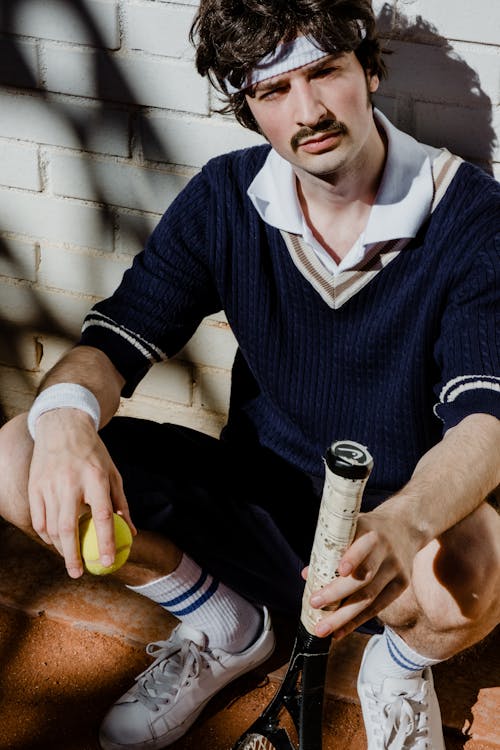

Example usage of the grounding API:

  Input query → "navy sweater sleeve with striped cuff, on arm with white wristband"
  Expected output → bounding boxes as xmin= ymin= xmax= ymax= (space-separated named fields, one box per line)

xmin=79 ymin=167 xmax=220 ymax=396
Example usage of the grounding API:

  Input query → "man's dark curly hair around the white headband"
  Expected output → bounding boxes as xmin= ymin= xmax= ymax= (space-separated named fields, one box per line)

xmin=189 ymin=0 xmax=386 ymax=131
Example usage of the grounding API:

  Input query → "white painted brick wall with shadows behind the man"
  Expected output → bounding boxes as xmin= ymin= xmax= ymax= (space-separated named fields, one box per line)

xmin=0 ymin=0 xmax=500 ymax=434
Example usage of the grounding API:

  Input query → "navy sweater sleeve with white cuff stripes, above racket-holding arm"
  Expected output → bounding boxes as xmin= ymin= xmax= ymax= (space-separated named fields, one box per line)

xmin=434 ymin=232 xmax=500 ymax=430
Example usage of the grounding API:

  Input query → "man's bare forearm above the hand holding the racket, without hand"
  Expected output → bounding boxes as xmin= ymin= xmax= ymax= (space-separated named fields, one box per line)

xmin=374 ymin=414 xmax=500 ymax=547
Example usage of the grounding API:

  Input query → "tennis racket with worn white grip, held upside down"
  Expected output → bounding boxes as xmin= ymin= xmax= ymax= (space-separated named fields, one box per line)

xmin=233 ymin=440 xmax=373 ymax=750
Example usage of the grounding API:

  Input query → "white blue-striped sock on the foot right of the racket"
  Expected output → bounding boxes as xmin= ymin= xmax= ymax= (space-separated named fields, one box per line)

xmin=364 ymin=626 xmax=440 ymax=685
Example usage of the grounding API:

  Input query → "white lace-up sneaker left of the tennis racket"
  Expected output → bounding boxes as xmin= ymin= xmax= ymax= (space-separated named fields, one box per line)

xmin=99 ymin=608 xmax=275 ymax=750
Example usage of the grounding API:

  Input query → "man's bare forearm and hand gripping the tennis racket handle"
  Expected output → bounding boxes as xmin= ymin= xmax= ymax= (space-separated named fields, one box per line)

xmin=305 ymin=414 xmax=500 ymax=638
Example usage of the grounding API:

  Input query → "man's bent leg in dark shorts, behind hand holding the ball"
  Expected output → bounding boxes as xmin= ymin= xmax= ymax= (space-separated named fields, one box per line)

xmin=0 ymin=415 xmax=319 ymax=615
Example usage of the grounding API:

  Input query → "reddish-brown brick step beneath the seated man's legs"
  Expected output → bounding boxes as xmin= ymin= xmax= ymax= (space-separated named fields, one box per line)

xmin=0 ymin=524 xmax=500 ymax=750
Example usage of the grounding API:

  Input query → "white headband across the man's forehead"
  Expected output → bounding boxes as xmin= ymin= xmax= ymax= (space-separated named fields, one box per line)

xmin=224 ymin=21 xmax=366 ymax=94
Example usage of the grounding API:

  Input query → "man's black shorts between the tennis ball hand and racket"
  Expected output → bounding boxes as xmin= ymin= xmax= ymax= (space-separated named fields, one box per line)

xmin=100 ymin=417 xmax=384 ymax=636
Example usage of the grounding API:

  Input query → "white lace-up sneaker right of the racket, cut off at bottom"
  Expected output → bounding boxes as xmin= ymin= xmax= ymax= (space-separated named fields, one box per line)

xmin=358 ymin=635 xmax=445 ymax=750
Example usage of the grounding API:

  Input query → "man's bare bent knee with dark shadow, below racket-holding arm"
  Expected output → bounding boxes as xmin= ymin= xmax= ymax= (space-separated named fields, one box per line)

xmin=381 ymin=503 xmax=500 ymax=659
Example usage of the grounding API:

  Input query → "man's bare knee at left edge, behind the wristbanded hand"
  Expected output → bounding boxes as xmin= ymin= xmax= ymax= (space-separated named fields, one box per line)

xmin=0 ymin=414 xmax=34 ymax=534
